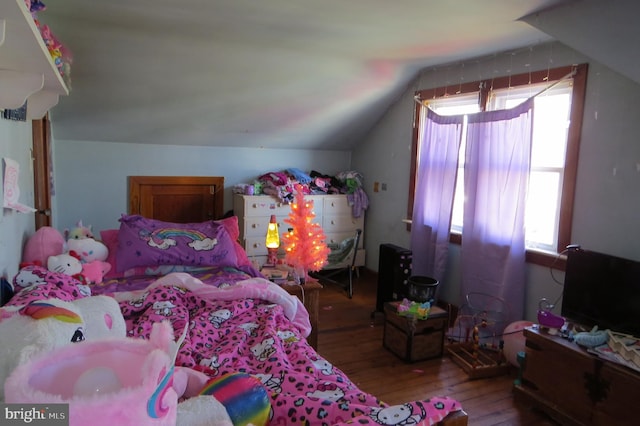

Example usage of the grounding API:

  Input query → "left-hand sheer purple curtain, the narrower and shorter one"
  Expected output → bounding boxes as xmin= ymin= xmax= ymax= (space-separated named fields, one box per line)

xmin=411 ymin=108 xmax=464 ymax=281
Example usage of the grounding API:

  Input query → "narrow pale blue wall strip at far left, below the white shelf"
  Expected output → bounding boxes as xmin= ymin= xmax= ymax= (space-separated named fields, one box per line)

xmin=0 ymin=119 xmax=35 ymax=282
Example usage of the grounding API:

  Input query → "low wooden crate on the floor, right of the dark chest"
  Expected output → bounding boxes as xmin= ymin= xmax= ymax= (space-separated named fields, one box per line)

xmin=447 ymin=342 xmax=509 ymax=379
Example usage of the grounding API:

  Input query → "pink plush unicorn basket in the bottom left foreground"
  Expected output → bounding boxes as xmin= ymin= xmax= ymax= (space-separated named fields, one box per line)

xmin=5 ymin=322 xmax=178 ymax=426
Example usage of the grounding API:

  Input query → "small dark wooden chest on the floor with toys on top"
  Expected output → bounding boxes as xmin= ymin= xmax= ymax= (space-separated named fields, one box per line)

xmin=383 ymin=302 xmax=448 ymax=362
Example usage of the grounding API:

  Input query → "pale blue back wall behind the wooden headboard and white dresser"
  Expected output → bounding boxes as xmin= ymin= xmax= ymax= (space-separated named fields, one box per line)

xmin=53 ymin=139 xmax=351 ymax=232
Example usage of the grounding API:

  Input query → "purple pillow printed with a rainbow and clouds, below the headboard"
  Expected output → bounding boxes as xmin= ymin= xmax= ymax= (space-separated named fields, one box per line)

xmin=116 ymin=214 xmax=238 ymax=272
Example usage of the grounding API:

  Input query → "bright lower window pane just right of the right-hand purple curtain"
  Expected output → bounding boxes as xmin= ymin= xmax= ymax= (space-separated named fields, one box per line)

xmin=525 ymin=172 xmax=560 ymax=250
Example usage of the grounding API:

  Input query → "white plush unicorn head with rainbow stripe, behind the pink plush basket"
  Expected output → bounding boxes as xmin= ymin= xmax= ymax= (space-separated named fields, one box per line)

xmin=0 ymin=296 xmax=126 ymax=400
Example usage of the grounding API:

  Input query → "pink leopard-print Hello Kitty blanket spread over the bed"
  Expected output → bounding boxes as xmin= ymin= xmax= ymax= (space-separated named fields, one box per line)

xmin=7 ymin=273 xmax=461 ymax=425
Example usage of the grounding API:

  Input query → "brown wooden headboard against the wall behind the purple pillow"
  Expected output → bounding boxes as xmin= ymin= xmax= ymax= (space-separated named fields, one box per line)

xmin=129 ymin=176 xmax=224 ymax=223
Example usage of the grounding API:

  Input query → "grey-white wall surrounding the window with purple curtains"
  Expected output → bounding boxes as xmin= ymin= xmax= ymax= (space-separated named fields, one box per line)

xmin=352 ymin=43 xmax=640 ymax=321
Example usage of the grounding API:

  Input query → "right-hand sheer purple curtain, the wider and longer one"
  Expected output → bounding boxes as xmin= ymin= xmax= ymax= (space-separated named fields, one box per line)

xmin=461 ymin=99 xmax=533 ymax=323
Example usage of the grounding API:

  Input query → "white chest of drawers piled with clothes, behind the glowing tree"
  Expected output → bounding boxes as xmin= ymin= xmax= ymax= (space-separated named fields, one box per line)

xmin=233 ymin=194 xmax=365 ymax=266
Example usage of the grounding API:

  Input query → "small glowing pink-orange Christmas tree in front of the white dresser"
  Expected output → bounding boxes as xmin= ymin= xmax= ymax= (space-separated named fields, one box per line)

xmin=282 ymin=185 xmax=329 ymax=278
